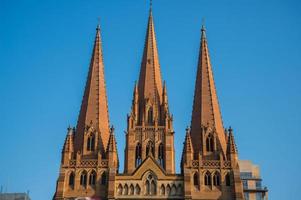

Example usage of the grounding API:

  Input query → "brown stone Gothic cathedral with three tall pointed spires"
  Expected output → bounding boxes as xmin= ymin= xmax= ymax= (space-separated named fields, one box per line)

xmin=53 ymin=6 xmax=244 ymax=200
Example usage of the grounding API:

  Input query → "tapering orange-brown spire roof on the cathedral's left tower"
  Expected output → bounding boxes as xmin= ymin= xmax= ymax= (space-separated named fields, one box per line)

xmin=76 ymin=25 xmax=109 ymax=150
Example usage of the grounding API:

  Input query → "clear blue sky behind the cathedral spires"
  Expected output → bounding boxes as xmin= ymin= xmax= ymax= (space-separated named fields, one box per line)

xmin=0 ymin=0 xmax=301 ymax=200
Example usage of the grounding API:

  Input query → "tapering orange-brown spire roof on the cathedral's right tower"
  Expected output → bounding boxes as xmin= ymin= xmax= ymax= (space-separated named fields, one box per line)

xmin=191 ymin=25 xmax=226 ymax=153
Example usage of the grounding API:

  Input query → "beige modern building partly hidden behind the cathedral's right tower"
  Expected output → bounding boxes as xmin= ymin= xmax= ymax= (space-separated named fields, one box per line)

xmin=239 ymin=160 xmax=268 ymax=200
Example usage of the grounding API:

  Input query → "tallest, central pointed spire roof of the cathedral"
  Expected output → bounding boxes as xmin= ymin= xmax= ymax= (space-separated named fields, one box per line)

xmin=138 ymin=8 xmax=162 ymax=102
